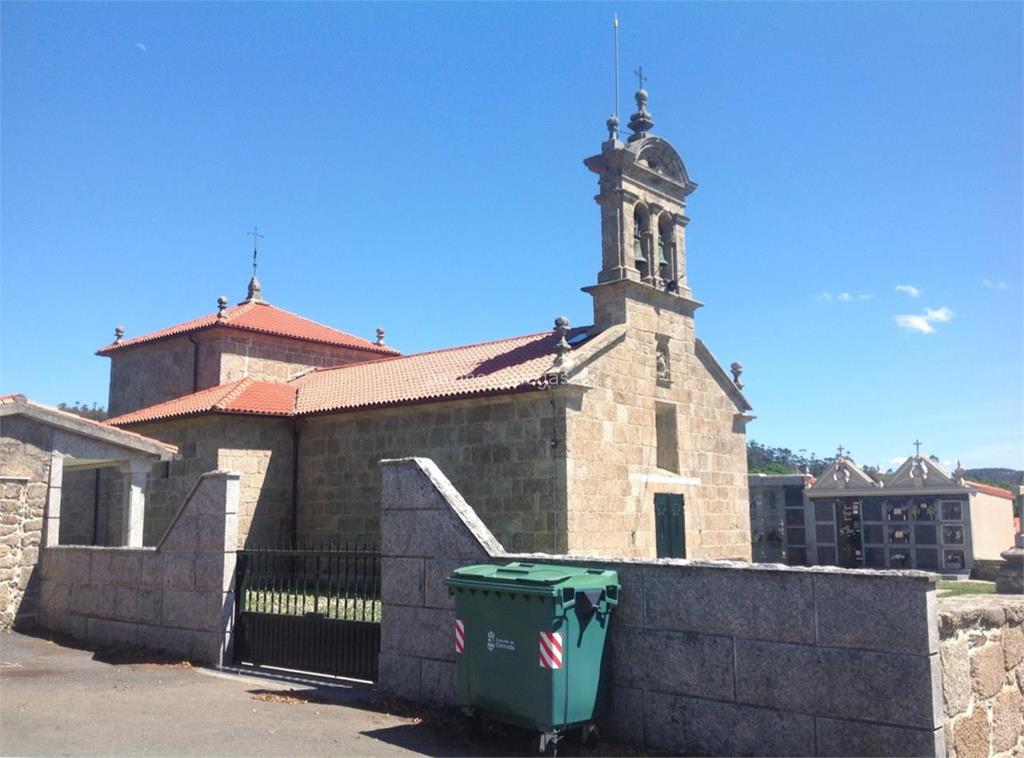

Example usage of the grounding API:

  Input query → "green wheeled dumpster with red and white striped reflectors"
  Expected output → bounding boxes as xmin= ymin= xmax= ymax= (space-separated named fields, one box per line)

xmin=447 ymin=562 xmax=621 ymax=750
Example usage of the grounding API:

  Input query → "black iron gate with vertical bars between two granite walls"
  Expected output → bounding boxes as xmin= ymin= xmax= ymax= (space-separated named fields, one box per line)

xmin=234 ymin=545 xmax=381 ymax=680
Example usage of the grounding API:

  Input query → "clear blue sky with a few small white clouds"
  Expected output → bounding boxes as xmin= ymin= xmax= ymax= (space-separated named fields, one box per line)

xmin=0 ymin=2 xmax=1024 ymax=467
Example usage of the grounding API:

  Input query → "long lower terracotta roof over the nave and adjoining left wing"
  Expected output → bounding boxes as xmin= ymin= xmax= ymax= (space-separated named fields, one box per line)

xmin=106 ymin=327 xmax=587 ymax=426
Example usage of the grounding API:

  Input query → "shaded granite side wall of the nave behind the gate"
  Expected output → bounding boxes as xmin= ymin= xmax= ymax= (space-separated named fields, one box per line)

xmin=299 ymin=391 xmax=565 ymax=552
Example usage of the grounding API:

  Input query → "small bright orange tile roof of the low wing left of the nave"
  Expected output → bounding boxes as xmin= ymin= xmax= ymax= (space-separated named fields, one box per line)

xmin=104 ymin=378 xmax=295 ymax=426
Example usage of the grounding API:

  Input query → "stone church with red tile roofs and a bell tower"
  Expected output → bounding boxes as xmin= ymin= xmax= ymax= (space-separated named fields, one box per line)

xmin=63 ymin=90 xmax=753 ymax=559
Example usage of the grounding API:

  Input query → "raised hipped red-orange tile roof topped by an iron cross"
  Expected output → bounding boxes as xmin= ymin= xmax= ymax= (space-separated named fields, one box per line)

xmin=96 ymin=300 xmax=398 ymax=355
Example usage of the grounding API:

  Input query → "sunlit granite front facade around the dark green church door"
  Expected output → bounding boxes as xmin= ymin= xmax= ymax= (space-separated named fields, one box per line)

xmin=569 ymin=287 xmax=751 ymax=560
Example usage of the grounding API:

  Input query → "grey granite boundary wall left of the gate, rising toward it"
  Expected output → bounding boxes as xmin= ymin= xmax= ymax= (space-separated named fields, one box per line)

xmin=39 ymin=471 xmax=240 ymax=666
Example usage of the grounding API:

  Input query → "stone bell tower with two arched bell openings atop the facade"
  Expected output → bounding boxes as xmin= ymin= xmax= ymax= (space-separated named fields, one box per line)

xmin=584 ymin=80 xmax=700 ymax=328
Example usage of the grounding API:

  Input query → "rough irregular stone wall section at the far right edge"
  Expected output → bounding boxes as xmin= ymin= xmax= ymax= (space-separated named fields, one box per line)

xmin=939 ymin=595 xmax=1024 ymax=758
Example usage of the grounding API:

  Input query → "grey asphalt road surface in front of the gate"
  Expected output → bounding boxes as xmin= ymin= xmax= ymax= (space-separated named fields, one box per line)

xmin=0 ymin=633 xmax=499 ymax=756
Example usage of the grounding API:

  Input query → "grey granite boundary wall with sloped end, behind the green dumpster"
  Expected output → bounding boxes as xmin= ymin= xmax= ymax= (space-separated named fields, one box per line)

xmin=379 ymin=459 xmax=945 ymax=755
